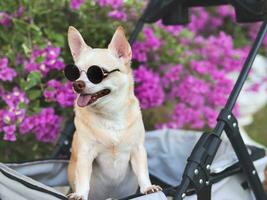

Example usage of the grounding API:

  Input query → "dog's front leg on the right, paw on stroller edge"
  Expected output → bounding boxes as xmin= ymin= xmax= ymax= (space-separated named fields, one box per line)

xmin=131 ymin=144 xmax=162 ymax=194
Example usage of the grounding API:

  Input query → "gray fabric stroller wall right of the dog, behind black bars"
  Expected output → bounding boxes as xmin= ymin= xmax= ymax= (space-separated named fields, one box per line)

xmin=145 ymin=129 xmax=240 ymax=185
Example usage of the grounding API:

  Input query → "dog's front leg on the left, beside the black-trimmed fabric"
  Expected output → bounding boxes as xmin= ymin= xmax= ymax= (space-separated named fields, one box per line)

xmin=68 ymin=150 xmax=94 ymax=200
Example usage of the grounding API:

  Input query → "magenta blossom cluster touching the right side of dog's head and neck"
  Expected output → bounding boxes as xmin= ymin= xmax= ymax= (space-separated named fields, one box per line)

xmin=134 ymin=65 xmax=164 ymax=109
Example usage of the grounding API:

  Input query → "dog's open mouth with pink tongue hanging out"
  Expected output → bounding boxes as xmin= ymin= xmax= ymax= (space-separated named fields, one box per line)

xmin=77 ymin=89 xmax=110 ymax=107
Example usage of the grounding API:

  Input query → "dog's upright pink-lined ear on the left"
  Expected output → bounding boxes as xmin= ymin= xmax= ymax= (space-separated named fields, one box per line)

xmin=68 ymin=26 xmax=91 ymax=61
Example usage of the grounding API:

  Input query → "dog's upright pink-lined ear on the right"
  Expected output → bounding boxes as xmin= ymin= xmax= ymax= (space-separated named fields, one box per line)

xmin=108 ymin=26 xmax=132 ymax=64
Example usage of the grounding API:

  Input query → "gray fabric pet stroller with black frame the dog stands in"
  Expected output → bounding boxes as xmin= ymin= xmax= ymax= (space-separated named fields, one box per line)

xmin=0 ymin=0 xmax=267 ymax=200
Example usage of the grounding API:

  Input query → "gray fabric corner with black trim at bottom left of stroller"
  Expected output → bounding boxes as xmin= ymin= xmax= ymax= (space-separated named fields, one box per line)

xmin=0 ymin=163 xmax=66 ymax=200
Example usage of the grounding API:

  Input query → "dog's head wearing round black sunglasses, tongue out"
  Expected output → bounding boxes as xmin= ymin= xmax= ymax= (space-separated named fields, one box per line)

xmin=68 ymin=27 xmax=133 ymax=107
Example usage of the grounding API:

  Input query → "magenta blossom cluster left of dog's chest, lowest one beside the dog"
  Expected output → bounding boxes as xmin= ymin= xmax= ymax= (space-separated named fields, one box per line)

xmin=20 ymin=108 xmax=62 ymax=142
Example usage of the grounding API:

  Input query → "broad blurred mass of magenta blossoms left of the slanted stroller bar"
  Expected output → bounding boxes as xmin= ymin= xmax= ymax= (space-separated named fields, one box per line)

xmin=158 ymin=32 xmax=247 ymax=129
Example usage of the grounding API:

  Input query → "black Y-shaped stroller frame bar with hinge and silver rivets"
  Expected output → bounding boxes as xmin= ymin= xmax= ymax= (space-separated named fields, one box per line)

xmin=173 ymin=21 xmax=267 ymax=200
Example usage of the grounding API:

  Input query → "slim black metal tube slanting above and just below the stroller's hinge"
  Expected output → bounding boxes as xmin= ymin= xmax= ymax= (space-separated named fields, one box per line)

xmin=213 ymin=21 xmax=267 ymax=136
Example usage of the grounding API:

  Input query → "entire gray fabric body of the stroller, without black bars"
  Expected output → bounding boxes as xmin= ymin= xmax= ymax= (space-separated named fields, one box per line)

xmin=0 ymin=129 xmax=267 ymax=200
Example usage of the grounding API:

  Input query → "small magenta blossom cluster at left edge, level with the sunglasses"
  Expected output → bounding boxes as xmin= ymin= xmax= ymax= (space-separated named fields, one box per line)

xmin=0 ymin=58 xmax=17 ymax=81
